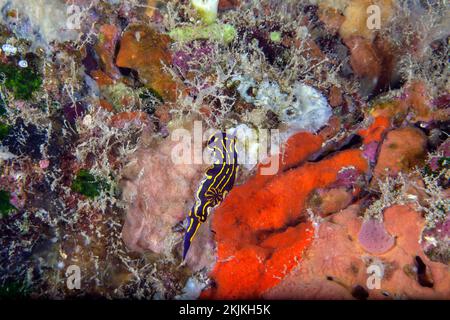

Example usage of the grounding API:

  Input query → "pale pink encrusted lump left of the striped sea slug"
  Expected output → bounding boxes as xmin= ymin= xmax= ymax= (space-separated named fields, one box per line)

xmin=122 ymin=137 xmax=206 ymax=255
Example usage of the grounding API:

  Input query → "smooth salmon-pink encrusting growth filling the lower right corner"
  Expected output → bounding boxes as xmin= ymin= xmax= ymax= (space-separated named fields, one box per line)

xmin=264 ymin=205 xmax=450 ymax=299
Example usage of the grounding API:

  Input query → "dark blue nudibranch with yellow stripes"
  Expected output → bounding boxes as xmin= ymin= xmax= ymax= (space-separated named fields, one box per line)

xmin=183 ymin=132 xmax=239 ymax=260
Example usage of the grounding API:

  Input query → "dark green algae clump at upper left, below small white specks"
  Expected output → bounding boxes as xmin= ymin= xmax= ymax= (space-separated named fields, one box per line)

xmin=0 ymin=63 xmax=42 ymax=100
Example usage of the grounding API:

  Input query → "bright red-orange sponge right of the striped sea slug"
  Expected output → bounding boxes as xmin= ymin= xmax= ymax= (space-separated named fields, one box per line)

xmin=202 ymin=133 xmax=368 ymax=299
